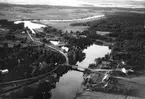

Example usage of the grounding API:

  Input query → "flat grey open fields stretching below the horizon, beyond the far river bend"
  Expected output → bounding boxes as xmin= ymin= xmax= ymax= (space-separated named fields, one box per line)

xmin=0 ymin=3 xmax=144 ymax=20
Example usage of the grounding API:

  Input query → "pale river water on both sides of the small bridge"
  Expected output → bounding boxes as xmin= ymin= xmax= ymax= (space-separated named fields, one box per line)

xmin=51 ymin=44 xmax=110 ymax=99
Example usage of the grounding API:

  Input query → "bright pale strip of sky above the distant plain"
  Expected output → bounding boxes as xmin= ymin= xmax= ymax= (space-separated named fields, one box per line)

xmin=0 ymin=0 xmax=145 ymax=8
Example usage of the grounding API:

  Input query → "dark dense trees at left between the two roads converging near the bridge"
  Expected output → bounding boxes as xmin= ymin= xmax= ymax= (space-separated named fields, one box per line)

xmin=0 ymin=44 xmax=66 ymax=81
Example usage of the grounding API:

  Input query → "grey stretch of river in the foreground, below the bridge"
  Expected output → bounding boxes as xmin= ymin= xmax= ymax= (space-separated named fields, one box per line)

xmin=51 ymin=71 xmax=83 ymax=99
